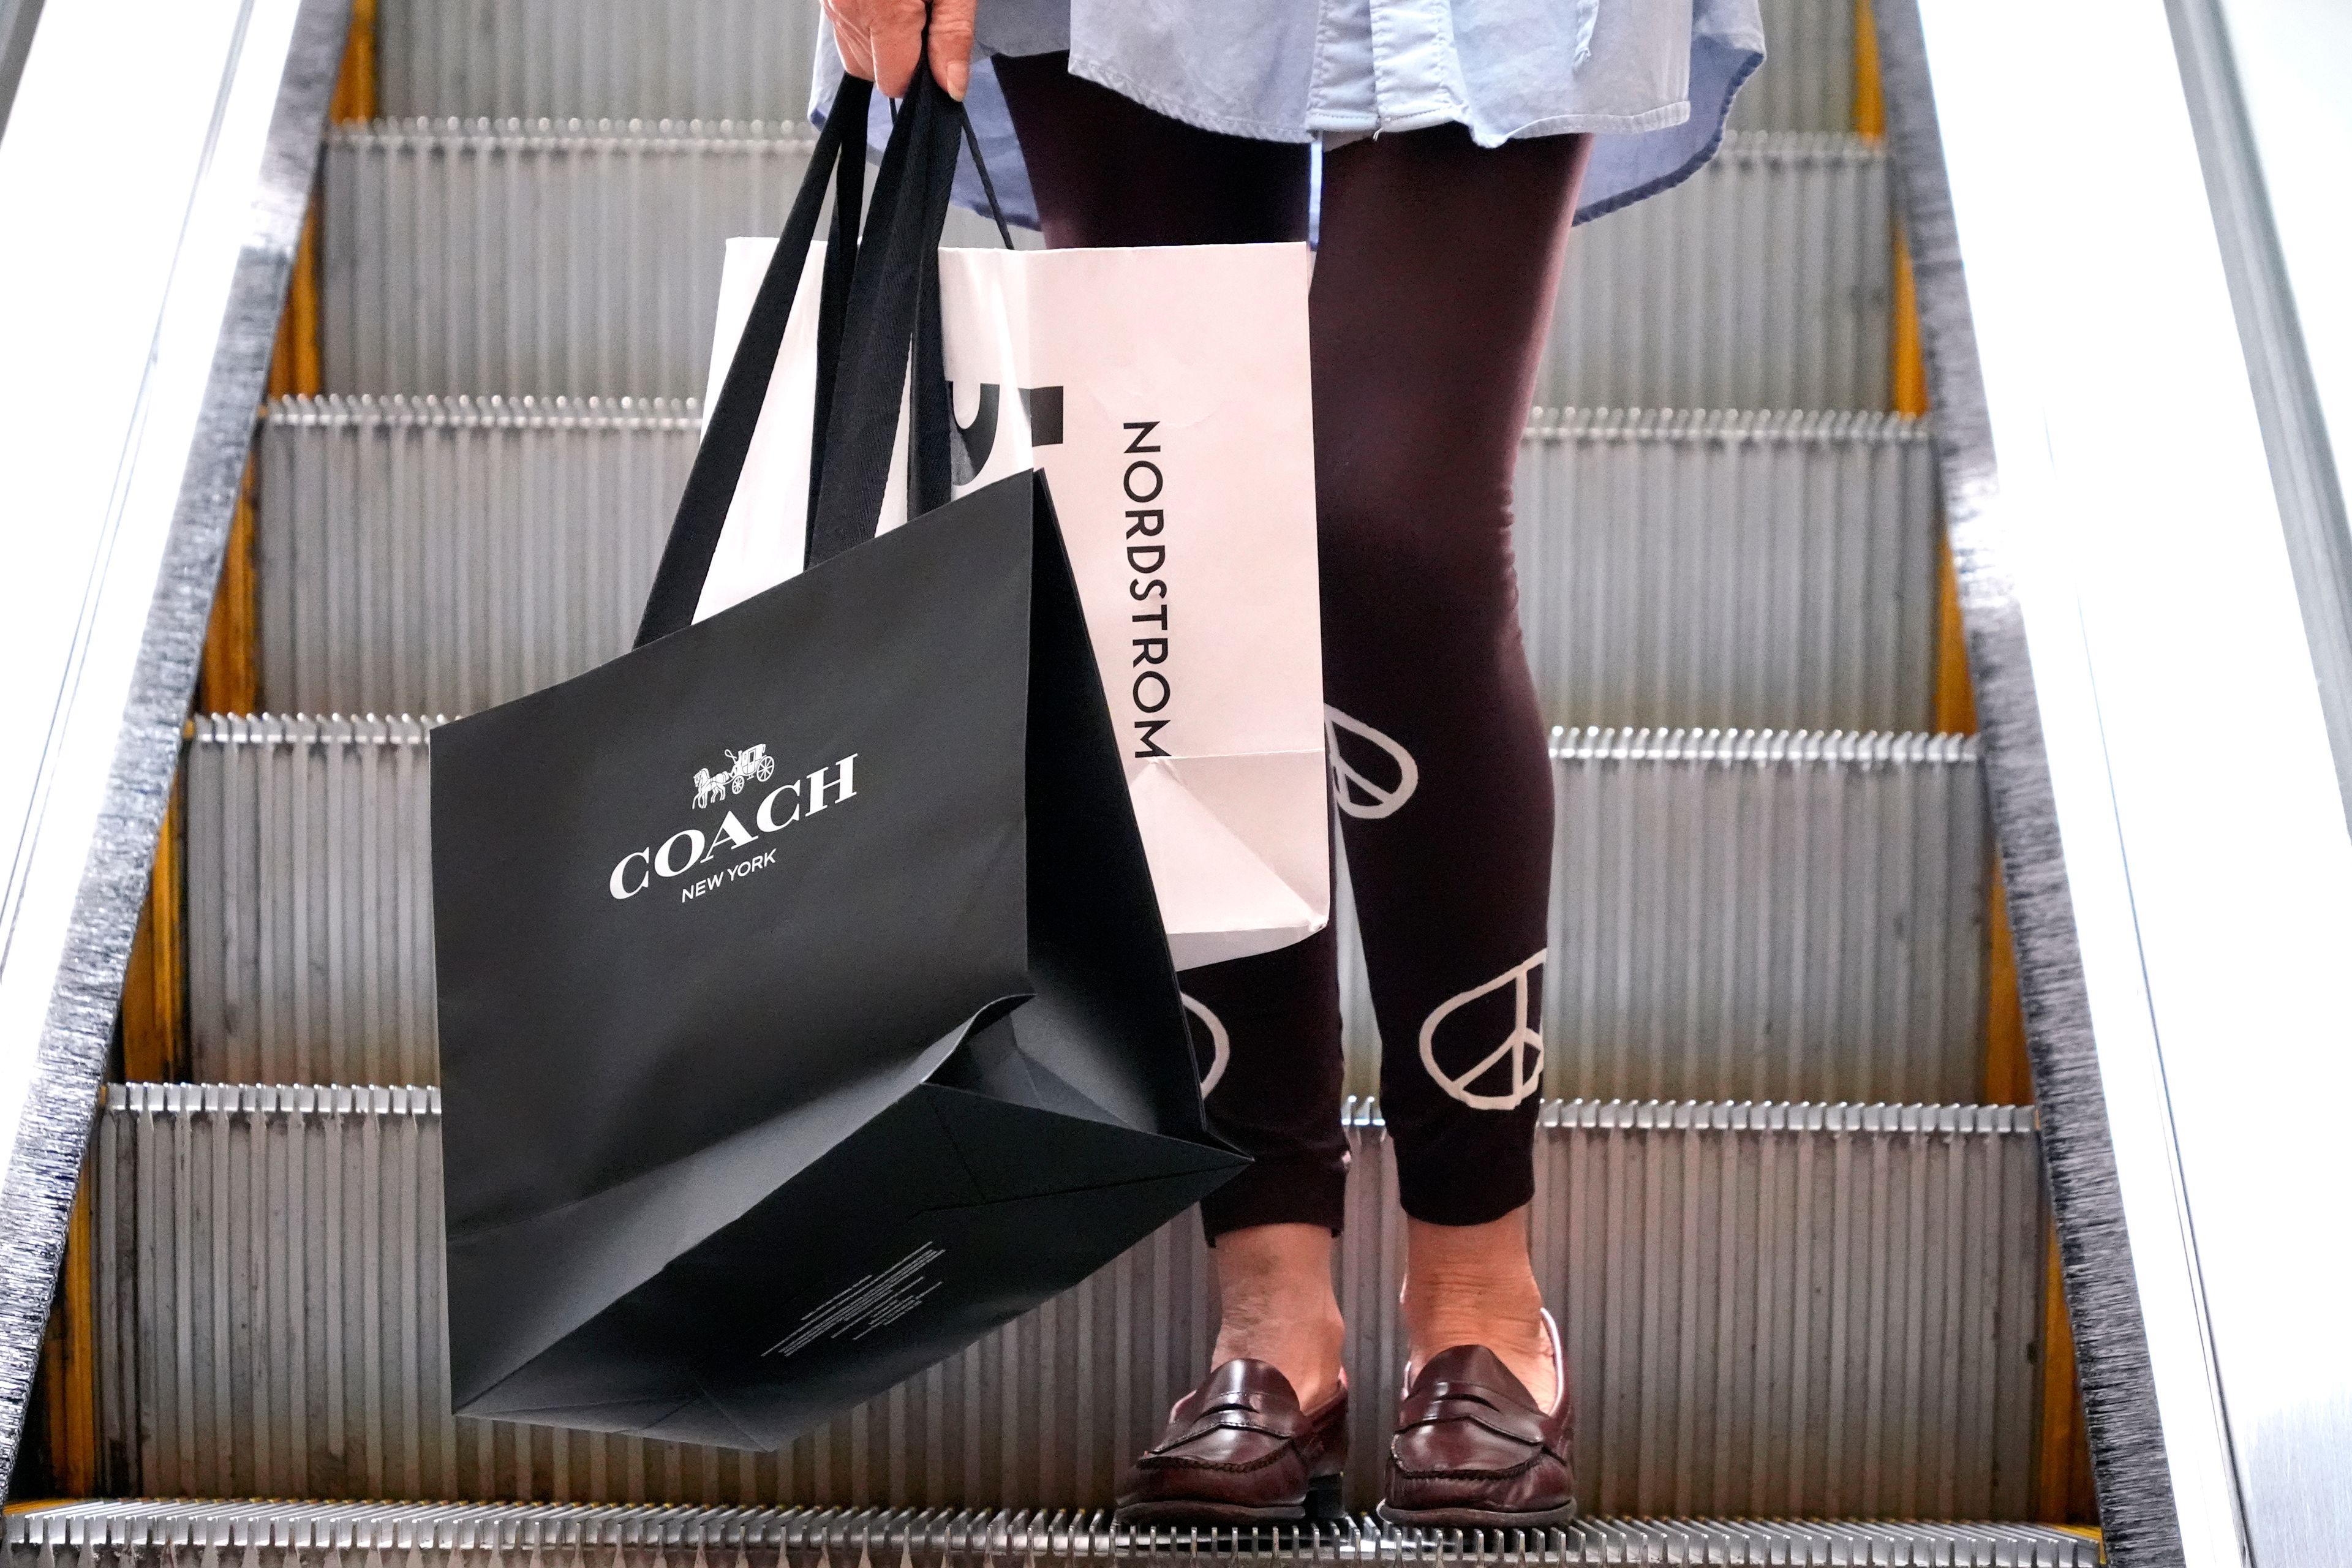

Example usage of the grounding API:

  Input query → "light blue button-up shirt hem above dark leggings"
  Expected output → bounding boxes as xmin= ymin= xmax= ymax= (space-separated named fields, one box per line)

xmin=809 ymin=0 xmax=1764 ymax=228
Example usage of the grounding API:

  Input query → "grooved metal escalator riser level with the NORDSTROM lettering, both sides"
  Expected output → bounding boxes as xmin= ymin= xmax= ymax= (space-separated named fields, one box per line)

xmin=257 ymin=398 xmax=1940 ymax=729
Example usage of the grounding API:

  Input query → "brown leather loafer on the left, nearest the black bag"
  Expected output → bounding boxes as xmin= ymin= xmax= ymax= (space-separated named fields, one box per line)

xmin=1117 ymin=1359 xmax=1348 ymax=1526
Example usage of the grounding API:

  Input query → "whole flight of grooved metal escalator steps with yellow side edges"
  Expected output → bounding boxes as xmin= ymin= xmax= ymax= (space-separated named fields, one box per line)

xmin=18 ymin=0 xmax=2352 ymax=1568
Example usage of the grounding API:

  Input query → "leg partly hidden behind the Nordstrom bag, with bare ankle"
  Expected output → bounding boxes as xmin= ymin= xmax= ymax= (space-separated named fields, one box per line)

xmin=995 ymin=54 xmax=1348 ymax=1411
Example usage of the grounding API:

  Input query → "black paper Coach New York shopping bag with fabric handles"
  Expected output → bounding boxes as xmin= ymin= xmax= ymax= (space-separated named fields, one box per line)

xmin=433 ymin=73 xmax=1242 ymax=1448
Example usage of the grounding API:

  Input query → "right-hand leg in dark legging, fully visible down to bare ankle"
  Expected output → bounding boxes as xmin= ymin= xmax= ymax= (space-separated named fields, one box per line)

xmin=1313 ymin=127 xmax=1590 ymax=1406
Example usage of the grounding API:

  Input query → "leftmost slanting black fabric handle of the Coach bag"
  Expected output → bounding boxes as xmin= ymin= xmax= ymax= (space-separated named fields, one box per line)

xmin=635 ymin=75 xmax=873 ymax=649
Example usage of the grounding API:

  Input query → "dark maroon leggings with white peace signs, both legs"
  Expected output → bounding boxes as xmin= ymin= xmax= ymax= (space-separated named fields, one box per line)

xmin=997 ymin=54 xmax=1593 ymax=1239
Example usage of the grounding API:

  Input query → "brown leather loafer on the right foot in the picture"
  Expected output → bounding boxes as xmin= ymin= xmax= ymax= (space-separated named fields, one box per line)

xmin=1381 ymin=1312 xmax=1576 ymax=1531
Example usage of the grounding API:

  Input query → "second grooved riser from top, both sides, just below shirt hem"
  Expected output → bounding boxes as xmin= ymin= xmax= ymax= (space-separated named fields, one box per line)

xmin=320 ymin=120 xmax=1893 ymax=409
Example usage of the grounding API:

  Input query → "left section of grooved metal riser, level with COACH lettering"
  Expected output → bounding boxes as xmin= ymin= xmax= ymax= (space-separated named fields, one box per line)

xmin=186 ymin=715 xmax=440 ymax=1084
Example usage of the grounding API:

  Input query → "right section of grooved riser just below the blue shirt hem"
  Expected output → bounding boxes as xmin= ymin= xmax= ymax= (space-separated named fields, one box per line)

xmin=1536 ymin=134 xmax=1893 ymax=409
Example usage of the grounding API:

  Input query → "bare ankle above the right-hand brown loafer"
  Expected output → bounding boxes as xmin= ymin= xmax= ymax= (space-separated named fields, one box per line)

xmin=1404 ymin=1208 xmax=1559 ymax=1411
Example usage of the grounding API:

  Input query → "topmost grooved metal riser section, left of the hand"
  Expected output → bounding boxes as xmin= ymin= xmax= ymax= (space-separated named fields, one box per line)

xmin=376 ymin=0 xmax=827 ymax=120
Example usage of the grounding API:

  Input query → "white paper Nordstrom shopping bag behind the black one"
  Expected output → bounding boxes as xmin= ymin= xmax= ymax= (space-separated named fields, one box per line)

xmin=696 ymin=239 xmax=1331 ymax=968
